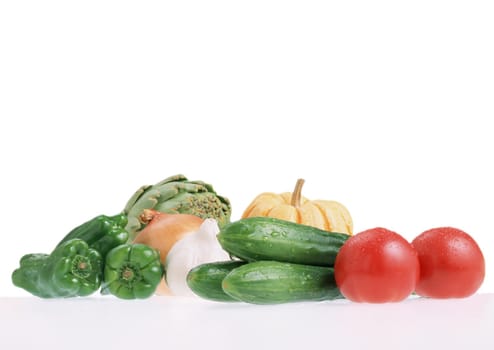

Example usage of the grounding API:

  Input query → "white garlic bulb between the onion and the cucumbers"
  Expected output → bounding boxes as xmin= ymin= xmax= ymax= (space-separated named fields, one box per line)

xmin=165 ymin=219 xmax=229 ymax=296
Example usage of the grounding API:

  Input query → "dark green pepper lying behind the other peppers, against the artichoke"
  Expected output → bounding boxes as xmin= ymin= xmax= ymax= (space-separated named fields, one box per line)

xmin=58 ymin=214 xmax=129 ymax=257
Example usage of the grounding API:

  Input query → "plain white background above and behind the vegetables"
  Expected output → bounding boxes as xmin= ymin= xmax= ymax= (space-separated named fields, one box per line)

xmin=0 ymin=0 xmax=494 ymax=296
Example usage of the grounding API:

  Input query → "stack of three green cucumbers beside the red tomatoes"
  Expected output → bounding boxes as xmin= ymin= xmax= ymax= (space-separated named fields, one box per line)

xmin=187 ymin=217 xmax=349 ymax=304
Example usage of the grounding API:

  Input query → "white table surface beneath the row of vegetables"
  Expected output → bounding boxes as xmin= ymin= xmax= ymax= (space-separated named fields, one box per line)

xmin=0 ymin=294 xmax=494 ymax=350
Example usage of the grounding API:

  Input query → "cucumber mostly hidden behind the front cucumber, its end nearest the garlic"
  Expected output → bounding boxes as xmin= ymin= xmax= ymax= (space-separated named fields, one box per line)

xmin=187 ymin=260 xmax=246 ymax=302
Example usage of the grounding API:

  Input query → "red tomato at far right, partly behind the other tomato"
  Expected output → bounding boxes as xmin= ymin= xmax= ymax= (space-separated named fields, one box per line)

xmin=412 ymin=227 xmax=485 ymax=298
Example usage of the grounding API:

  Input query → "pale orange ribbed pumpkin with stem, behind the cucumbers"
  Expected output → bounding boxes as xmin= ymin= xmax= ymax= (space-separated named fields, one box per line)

xmin=242 ymin=179 xmax=353 ymax=235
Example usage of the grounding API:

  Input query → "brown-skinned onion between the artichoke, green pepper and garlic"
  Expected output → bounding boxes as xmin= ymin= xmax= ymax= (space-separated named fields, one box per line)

xmin=132 ymin=209 xmax=204 ymax=295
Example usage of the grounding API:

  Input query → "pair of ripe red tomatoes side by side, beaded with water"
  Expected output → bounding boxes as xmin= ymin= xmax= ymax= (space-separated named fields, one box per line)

xmin=335 ymin=227 xmax=485 ymax=303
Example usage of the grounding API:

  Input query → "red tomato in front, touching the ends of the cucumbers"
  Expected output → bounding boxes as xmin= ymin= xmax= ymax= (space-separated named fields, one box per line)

xmin=334 ymin=227 xmax=420 ymax=303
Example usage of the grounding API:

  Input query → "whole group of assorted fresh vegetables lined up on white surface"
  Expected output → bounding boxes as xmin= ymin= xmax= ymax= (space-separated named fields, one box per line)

xmin=12 ymin=175 xmax=485 ymax=304
